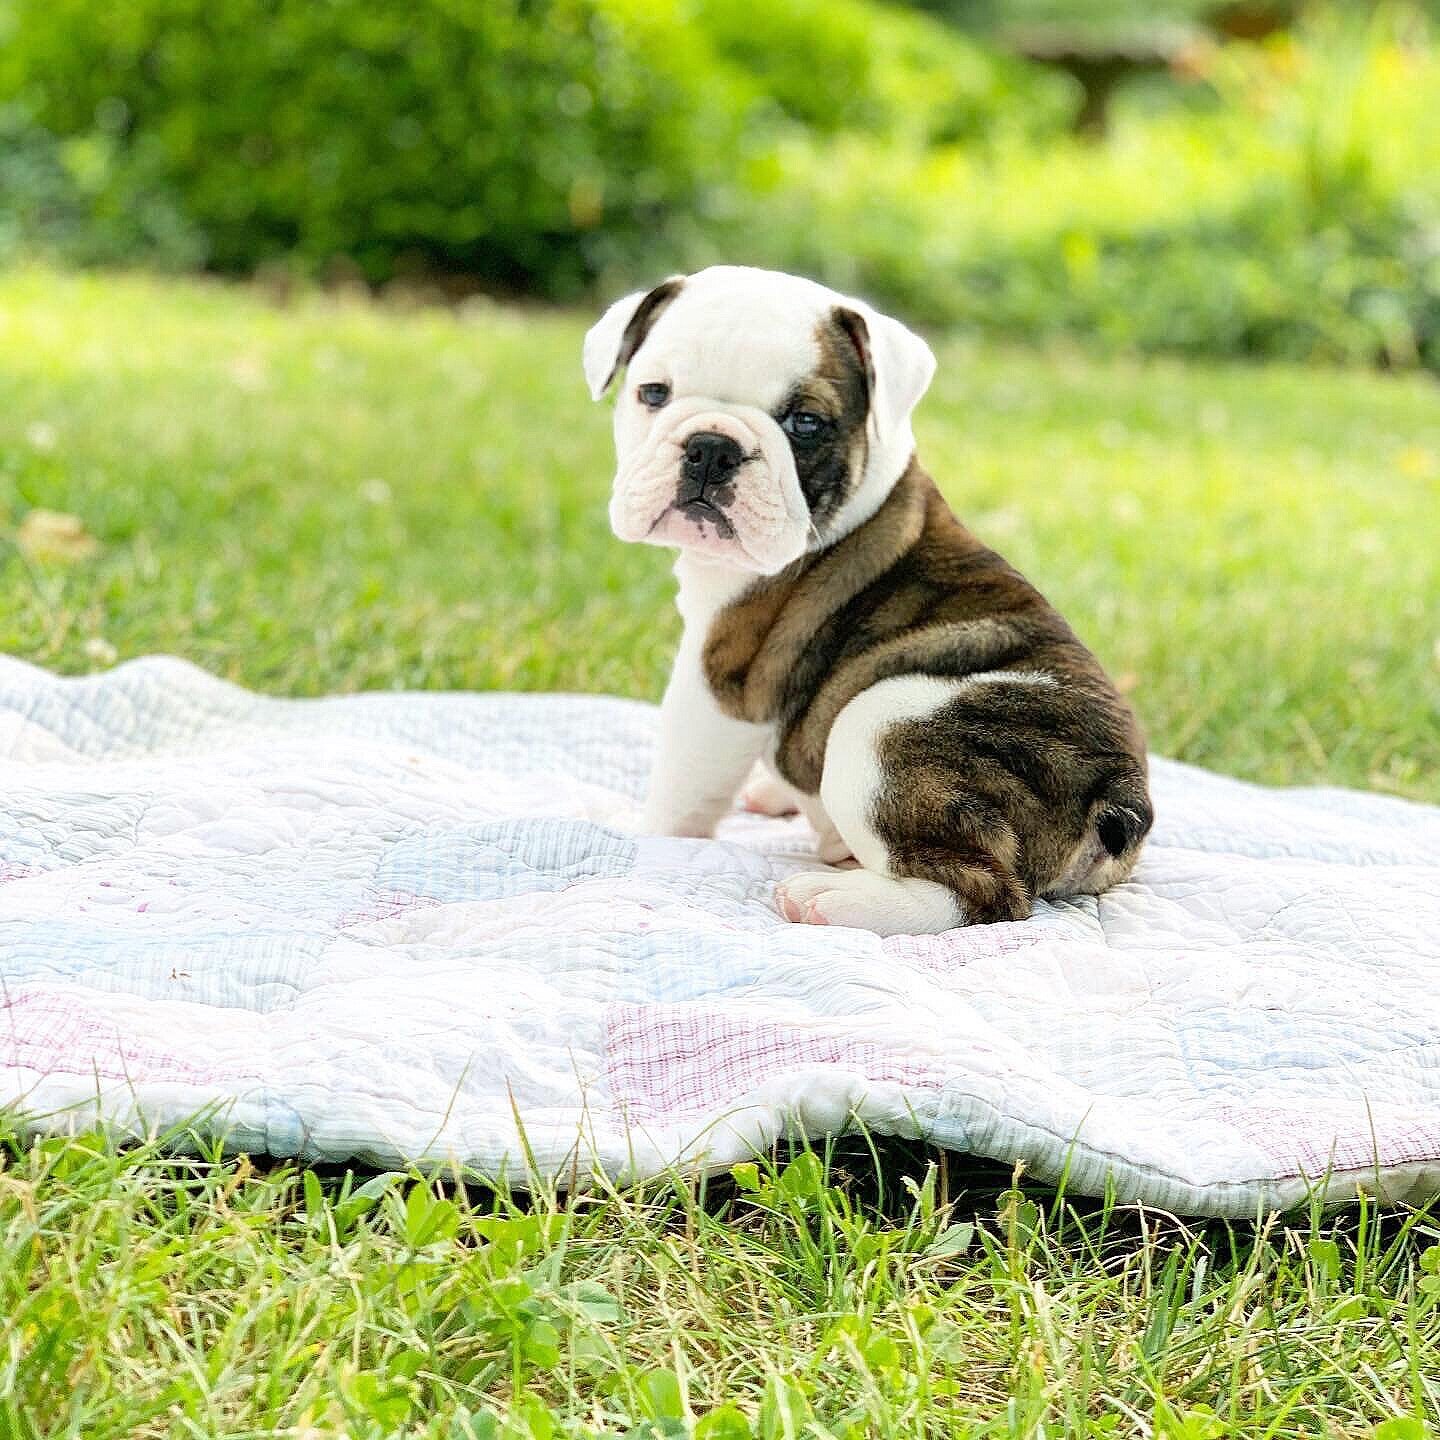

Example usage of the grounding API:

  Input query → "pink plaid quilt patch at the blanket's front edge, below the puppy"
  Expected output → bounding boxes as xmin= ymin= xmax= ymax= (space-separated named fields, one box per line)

xmin=605 ymin=1005 xmax=943 ymax=1120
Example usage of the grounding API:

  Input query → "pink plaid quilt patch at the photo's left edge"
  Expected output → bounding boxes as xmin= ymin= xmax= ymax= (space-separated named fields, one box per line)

xmin=0 ymin=989 xmax=217 ymax=1084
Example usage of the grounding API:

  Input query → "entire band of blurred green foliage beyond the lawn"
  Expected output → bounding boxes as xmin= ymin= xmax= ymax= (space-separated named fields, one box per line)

xmin=0 ymin=0 xmax=1440 ymax=367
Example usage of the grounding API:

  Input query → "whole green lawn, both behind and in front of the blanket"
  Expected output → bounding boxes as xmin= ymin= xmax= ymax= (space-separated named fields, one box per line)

xmin=0 ymin=269 xmax=1440 ymax=1440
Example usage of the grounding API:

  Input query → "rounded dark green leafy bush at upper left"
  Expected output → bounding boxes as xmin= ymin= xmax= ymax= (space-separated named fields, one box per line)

xmin=0 ymin=0 xmax=749 ymax=291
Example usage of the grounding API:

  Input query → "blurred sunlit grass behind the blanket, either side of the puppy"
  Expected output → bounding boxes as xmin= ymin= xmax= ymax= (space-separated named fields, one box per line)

xmin=0 ymin=271 xmax=1440 ymax=799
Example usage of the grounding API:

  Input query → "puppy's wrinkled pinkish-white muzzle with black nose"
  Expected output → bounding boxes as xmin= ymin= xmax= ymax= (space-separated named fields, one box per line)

xmin=611 ymin=400 xmax=811 ymax=575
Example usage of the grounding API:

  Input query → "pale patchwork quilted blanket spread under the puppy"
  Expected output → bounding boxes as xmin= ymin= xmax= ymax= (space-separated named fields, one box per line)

xmin=0 ymin=658 xmax=1440 ymax=1214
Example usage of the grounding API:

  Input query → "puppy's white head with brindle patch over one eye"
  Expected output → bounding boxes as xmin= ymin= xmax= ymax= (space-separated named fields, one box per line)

xmin=585 ymin=265 xmax=935 ymax=575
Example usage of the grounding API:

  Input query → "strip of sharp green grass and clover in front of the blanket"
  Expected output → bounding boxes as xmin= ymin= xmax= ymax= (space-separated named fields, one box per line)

xmin=0 ymin=1136 xmax=1440 ymax=1440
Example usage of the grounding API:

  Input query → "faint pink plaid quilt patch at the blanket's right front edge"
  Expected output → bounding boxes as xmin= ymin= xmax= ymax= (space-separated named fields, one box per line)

xmin=1217 ymin=1102 xmax=1440 ymax=1179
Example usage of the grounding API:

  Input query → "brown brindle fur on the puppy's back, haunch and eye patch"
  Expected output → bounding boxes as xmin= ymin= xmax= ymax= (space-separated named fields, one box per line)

xmin=704 ymin=317 xmax=1152 ymax=922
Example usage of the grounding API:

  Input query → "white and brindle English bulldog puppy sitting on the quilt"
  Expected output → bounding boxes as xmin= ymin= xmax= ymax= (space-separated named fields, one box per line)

xmin=583 ymin=265 xmax=1152 ymax=935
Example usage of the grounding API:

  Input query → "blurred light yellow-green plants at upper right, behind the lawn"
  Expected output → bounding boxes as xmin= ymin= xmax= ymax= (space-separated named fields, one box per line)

xmin=753 ymin=9 xmax=1440 ymax=370
